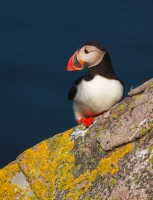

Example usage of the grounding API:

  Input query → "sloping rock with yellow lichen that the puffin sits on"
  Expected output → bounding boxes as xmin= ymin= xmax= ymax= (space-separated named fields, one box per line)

xmin=0 ymin=79 xmax=153 ymax=200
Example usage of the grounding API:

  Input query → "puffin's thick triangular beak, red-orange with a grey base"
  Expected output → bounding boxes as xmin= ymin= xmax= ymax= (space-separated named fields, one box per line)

xmin=67 ymin=52 xmax=84 ymax=71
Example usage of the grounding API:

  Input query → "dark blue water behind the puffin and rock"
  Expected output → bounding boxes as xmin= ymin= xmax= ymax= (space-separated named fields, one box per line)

xmin=0 ymin=0 xmax=153 ymax=167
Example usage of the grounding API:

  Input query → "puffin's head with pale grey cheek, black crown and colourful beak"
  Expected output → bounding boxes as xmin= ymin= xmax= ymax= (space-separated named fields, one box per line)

xmin=67 ymin=42 xmax=106 ymax=71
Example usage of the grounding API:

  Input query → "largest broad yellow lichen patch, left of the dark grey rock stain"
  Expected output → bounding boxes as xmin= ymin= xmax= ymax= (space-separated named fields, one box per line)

xmin=20 ymin=129 xmax=74 ymax=200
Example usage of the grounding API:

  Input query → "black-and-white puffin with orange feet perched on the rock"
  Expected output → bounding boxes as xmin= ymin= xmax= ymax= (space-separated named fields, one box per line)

xmin=67 ymin=42 xmax=124 ymax=127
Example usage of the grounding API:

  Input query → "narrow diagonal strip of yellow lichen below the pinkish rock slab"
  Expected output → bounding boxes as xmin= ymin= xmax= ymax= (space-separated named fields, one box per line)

xmin=66 ymin=144 xmax=132 ymax=200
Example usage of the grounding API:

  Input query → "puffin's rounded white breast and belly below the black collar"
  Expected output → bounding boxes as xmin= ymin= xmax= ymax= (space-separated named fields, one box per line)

xmin=74 ymin=75 xmax=123 ymax=116
